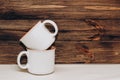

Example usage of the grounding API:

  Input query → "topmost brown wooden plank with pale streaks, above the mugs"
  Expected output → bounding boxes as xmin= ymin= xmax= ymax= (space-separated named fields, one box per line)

xmin=0 ymin=0 xmax=120 ymax=19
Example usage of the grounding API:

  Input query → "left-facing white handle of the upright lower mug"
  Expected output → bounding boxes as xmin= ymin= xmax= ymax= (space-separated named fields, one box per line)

xmin=17 ymin=51 xmax=28 ymax=69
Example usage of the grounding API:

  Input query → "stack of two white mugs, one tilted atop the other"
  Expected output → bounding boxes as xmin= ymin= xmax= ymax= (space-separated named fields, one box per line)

xmin=17 ymin=20 xmax=58 ymax=74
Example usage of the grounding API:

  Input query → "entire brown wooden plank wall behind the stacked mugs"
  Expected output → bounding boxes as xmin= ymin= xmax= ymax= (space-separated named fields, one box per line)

xmin=0 ymin=0 xmax=120 ymax=64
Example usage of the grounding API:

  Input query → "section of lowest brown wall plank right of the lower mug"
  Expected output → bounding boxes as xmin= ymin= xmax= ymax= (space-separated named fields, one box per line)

xmin=56 ymin=41 xmax=120 ymax=63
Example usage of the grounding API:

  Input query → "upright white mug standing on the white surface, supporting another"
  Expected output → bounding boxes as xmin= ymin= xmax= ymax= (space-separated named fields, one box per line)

xmin=17 ymin=47 xmax=55 ymax=75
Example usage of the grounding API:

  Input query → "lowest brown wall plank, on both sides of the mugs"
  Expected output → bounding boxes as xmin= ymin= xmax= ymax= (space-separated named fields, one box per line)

xmin=0 ymin=41 xmax=120 ymax=64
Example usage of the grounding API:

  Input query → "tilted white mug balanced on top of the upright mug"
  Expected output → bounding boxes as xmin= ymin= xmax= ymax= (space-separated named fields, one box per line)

xmin=20 ymin=20 xmax=58 ymax=50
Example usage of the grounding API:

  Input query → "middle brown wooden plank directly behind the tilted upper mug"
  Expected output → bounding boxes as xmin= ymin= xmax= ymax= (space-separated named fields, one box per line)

xmin=0 ymin=20 xmax=120 ymax=41
